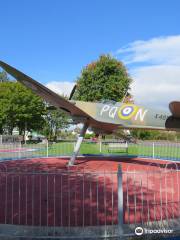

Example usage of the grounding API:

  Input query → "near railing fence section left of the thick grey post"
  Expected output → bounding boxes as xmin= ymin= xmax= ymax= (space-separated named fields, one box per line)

xmin=0 ymin=163 xmax=118 ymax=236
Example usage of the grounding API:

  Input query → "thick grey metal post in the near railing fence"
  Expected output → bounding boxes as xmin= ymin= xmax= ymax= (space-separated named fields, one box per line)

xmin=117 ymin=165 xmax=123 ymax=237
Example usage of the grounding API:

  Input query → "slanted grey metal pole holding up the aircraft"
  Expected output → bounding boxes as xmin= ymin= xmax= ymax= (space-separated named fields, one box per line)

xmin=68 ymin=123 xmax=88 ymax=166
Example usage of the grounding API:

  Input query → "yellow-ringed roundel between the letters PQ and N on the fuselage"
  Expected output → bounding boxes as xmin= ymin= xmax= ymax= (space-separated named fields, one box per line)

xmin=118 ymin=105 xmax=137 ymax=120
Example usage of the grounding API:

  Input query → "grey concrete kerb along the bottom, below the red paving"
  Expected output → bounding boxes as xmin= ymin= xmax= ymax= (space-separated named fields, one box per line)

xmin=0 ymin=218 xmax=180 ymax=240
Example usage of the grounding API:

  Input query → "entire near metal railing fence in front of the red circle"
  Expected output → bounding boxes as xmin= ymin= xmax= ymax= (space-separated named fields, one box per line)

xmin=0 ymin=163 xmax=180 ymax=237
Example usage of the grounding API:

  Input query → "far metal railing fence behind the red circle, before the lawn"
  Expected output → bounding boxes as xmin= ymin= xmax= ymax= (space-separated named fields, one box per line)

xmin=0 ymin=140 xmax=180 ymax=160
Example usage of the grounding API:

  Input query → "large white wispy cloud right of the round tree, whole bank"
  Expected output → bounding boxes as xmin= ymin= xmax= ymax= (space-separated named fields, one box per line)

xmin=116 ymin=35 xmax=180 ymax=108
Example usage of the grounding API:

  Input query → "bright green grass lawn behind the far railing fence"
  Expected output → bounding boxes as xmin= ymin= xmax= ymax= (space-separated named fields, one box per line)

xmin=26 ymin=142 xmax=180 ymax=159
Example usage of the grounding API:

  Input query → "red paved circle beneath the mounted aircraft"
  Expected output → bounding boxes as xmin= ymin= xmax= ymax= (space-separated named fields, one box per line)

xmin=0 ymin=157 xmax=180 ymax=226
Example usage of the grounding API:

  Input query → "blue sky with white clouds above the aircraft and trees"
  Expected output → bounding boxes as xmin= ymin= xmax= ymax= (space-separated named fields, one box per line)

xmin=0 ymin=0 xmax=180 ymax=108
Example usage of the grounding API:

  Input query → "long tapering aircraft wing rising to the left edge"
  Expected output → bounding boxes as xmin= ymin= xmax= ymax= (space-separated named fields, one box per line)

xmin=0 ymin=61 xmax=88 ymax=117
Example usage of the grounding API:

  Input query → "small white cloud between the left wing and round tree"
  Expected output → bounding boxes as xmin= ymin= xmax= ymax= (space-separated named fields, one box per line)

xmin=46 ymin=81 xmax=75 ymax=96
